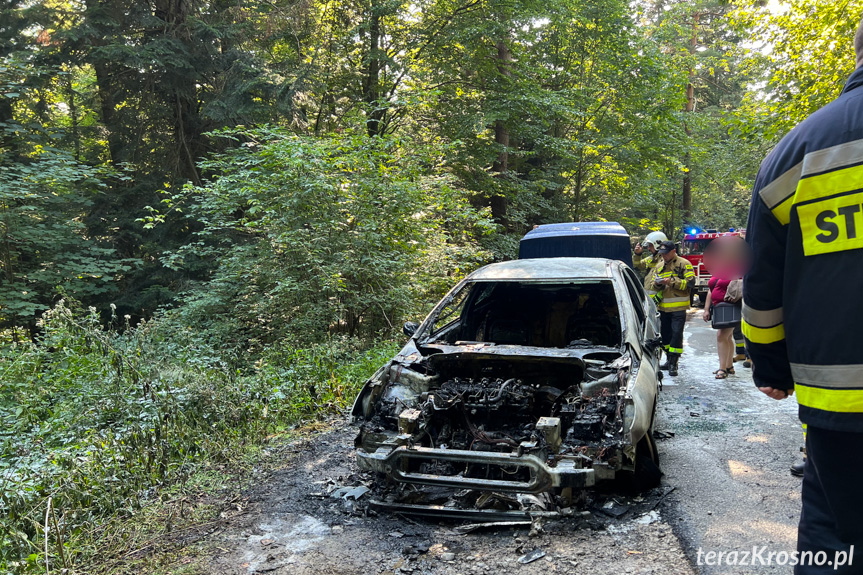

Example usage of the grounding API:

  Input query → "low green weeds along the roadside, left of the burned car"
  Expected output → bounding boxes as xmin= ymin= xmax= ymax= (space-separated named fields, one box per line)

xmin=0 ymin=302 xmax=393 ymax=573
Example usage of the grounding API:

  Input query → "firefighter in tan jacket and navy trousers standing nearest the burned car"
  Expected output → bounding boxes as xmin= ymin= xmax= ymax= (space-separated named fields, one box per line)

xmin=648 ymin=240 xmax=695 ymax=375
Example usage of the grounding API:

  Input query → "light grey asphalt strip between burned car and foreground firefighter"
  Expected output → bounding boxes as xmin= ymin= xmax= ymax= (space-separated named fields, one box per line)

xmin=657 ymin=309 xmax=803 ymax=573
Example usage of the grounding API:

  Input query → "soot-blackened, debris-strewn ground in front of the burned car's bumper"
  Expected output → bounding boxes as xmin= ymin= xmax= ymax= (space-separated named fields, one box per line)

xmin=195 ymin=421 xmax=695 ymax=575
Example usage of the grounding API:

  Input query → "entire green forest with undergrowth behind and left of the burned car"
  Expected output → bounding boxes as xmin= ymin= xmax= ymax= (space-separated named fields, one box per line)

xmin=0 ymin=0 xmax=863 ymax=573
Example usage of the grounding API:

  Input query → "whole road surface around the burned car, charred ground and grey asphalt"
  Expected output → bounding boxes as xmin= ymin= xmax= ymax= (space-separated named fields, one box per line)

xmin=194 ymin=311 xmax=802 ymax=575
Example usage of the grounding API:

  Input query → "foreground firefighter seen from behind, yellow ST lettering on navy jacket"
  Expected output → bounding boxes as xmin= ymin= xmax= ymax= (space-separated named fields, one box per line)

xmin=742 ymin=16 xmax=863 ymax=575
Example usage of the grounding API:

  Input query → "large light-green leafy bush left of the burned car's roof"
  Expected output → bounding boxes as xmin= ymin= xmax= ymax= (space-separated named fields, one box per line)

xmin=147 ymin=127 xmax=494 ymax=355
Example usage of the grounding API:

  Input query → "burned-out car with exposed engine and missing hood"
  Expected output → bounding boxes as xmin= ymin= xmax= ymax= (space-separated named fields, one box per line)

xmin=352 ymin=257 xmax=661 ymax=516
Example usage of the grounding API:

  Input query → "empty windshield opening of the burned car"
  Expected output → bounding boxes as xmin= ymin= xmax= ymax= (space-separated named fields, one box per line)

xmin=435 ymin=281 xmax=621 ymax=348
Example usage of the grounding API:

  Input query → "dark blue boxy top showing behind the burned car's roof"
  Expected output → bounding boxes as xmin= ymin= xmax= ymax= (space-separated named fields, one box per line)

xmin=518 ymin=222 xmax=632 ymax=266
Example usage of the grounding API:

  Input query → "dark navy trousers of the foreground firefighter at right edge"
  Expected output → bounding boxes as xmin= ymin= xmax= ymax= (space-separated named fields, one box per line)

xmin=794 ymin=425 xmax=863 ymax=575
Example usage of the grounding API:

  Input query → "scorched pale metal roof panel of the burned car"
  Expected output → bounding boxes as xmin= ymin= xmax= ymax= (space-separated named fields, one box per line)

xmin=466 ymin=258 xmax=621 ymax=281
